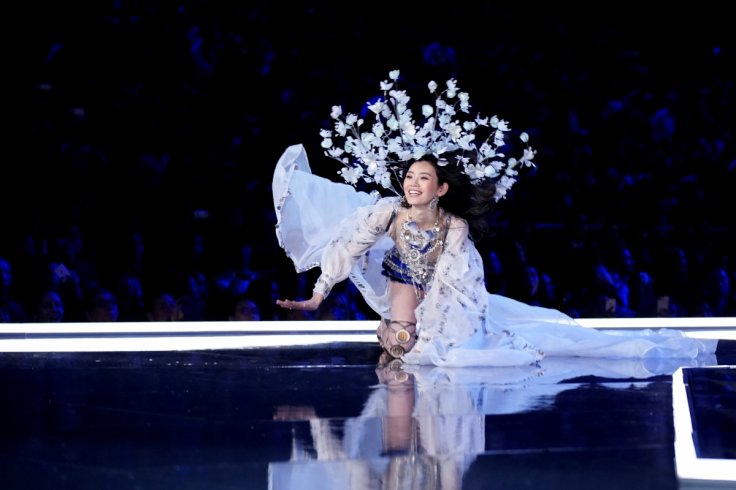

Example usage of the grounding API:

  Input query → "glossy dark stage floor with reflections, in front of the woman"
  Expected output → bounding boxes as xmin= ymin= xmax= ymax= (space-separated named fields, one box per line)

xmin=0 ymin=324 xmax=736 ymax=490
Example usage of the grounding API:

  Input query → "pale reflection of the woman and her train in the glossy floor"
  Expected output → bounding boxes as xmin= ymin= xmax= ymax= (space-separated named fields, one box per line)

xmin=269 ymin=356 xmax=712 ymax=490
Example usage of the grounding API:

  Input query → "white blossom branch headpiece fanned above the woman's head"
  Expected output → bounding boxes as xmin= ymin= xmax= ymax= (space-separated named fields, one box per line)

xmin=320 ymin=70 xmax=536 ymax=201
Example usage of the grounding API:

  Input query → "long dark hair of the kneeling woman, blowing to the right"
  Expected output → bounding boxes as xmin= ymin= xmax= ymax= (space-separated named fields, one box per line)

xmin=401 ymin=153 xmax=496 ymax=241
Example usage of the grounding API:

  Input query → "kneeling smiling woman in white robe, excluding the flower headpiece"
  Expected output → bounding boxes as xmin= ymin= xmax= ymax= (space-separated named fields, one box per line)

xmin=274 ymin=145 xmax=715 ymax=366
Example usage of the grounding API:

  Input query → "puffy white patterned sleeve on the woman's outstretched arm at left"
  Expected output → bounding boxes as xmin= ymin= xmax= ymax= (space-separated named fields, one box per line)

xmin=314 ymin=198 xmax=396 ymax=297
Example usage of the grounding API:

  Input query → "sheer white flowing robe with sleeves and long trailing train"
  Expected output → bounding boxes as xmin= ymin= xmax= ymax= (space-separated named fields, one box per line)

xmin=273 ymin=145 xmax=717 ymax=367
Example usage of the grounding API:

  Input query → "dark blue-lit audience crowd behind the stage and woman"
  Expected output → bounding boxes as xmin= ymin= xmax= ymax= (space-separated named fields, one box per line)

xmin=0 ymin=4 xmax=736 ymax=323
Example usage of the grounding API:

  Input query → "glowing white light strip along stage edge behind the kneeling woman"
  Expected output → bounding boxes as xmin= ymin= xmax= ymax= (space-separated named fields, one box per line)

xmin=0 ymin=317 xmax=736 ymax=352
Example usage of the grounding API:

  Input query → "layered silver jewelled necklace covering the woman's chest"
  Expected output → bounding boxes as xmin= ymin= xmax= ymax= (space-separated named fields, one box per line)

xmin=400 ymin=208 xmax=443 ymax=295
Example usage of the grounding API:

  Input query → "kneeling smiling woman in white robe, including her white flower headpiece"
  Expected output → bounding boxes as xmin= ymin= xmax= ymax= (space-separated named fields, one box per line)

xmin=273 ymin=72 xmax=715 ymax=366
